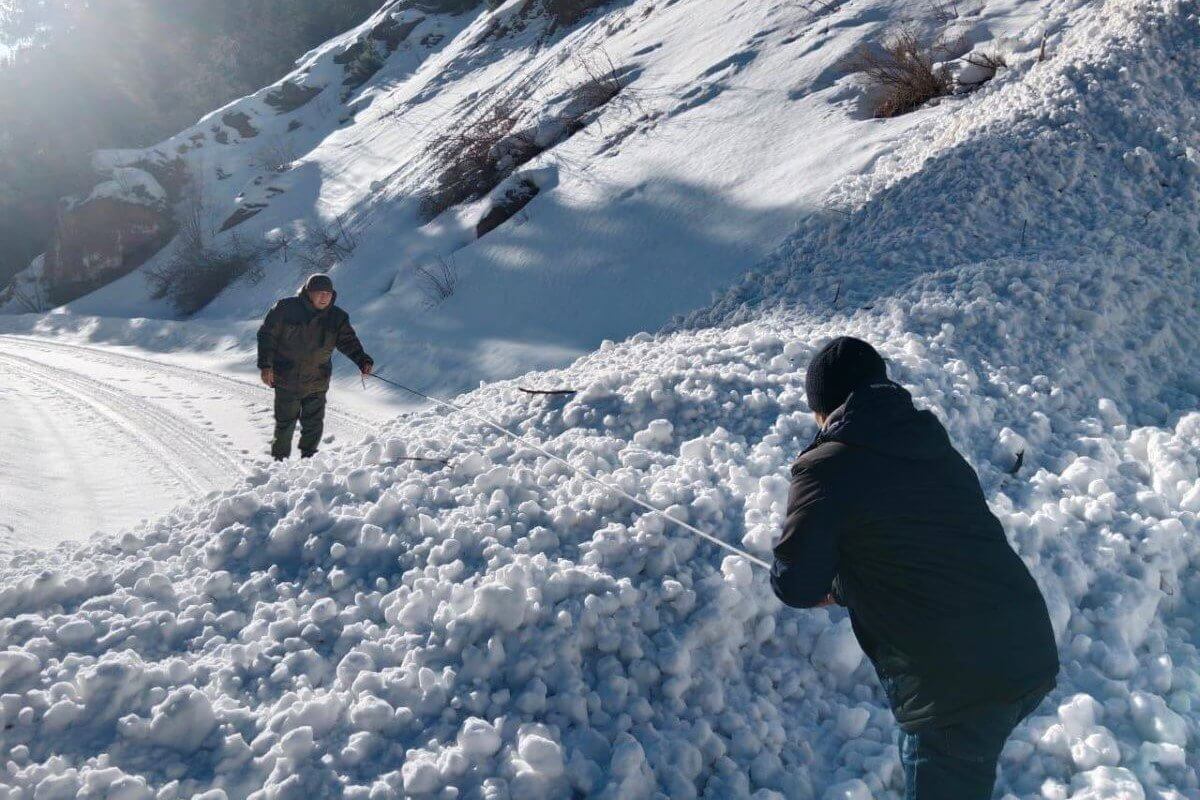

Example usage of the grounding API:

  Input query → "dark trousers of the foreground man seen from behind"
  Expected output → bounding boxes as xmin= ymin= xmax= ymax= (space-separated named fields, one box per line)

xmin=900 ymin=692 xmax=1045 ymax=800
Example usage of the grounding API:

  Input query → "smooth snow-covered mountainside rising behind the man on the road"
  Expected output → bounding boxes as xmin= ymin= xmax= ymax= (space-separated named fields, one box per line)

xmin=5 ymin=0 xmax=1079 ymax=391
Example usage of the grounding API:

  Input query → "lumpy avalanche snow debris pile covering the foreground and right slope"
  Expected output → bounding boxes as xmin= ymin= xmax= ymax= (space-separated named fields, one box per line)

xmin=0 ymin=1 xmax=1200 ymax=800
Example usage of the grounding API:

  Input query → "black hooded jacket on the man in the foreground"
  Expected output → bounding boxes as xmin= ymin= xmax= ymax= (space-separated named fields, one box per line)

xmin=772 ymin=383 xmax=1058 ymax=730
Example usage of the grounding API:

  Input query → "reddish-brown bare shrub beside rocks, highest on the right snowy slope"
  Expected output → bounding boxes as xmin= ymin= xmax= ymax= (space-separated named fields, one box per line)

xmin=850 ymin=24 xmax=952 ymax=118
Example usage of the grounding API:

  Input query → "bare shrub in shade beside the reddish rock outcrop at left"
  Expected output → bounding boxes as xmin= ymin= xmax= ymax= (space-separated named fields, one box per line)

xmin=145 ymin=199 xmax=274 ymax=314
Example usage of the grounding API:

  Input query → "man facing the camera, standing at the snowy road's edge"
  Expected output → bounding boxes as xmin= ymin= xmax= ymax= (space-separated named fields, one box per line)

xmin=258 ymin=272 xmax=374 ymax=461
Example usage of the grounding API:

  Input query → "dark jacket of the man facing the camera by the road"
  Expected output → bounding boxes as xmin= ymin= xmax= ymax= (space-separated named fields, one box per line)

xmin=258 ymin=290 xmax=364 ymax=395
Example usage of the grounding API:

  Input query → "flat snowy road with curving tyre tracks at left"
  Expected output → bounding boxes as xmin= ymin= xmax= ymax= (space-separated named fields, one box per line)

xmin=0 ymin=336 xmax=384 ymax=548
